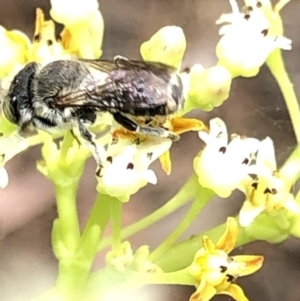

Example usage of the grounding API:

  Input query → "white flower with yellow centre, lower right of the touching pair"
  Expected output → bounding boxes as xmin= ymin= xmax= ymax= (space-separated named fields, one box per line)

xmin=239 ymin=137 xmax=300 ymax=227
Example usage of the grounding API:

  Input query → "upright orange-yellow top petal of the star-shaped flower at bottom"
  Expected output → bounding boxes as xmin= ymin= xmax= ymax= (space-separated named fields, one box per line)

xmin=216 ymin=217 xmax=238 ymax=254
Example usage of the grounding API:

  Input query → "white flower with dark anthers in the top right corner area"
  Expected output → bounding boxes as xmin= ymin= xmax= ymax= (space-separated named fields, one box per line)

xmin=216 ymin=0 xmax=292 ymax=76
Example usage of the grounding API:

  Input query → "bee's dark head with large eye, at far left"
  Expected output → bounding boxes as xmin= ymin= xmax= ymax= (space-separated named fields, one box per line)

xmin=3 ymin=62 xmax=38 ymax=127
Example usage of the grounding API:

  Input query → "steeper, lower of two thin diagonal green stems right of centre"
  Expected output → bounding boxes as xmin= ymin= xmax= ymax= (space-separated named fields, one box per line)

xmin=149 ymin=186 xmax=215 ymax=261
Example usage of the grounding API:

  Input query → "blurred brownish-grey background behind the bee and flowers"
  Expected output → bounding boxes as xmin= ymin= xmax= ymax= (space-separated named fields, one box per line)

xmin=0 ymin=0 xmax=300 ymax=301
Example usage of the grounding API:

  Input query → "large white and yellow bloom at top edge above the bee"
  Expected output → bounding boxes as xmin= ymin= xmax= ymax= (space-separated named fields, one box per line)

xmin=50 ymin=0 xmax=104 ymax=59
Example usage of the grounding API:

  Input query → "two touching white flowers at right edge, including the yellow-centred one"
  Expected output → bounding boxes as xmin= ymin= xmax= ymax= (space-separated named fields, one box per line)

xmin=194 ymin=118 xmax=300 ymax=227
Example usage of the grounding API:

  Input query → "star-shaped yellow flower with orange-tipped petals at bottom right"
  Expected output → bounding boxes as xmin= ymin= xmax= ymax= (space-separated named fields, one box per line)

xmin=189 ymin=218 xmax=263 ymax=301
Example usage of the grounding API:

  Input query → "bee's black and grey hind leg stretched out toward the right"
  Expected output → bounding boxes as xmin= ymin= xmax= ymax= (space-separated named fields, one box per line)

xmin=113 ymin=113 xmax=179 ymax=141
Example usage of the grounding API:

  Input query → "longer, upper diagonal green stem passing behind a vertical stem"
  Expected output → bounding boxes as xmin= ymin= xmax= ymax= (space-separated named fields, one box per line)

xmin=98 ymin=174 xmax=199 ymax=251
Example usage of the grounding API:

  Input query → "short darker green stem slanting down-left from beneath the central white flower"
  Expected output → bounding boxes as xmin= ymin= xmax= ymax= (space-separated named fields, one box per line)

xmin=81 ymin=193 xmax=110 ymax=241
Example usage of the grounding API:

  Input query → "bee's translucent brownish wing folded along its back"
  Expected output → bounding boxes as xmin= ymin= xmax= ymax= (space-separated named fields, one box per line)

xmin=57 ymin=59 xmax=175 ymax=114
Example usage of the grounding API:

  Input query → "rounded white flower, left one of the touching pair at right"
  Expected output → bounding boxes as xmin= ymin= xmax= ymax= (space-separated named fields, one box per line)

xmin=194 ymin=118 xmax=260 ymax=198
